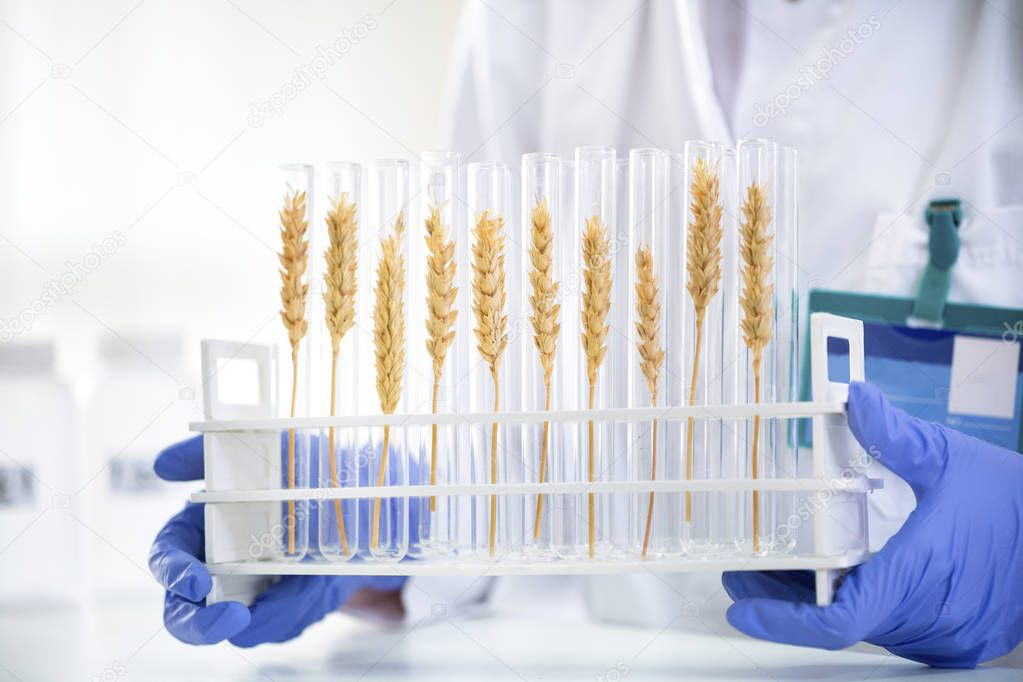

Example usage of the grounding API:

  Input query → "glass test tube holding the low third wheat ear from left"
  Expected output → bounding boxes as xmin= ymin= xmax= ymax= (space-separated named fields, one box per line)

xmin=359 ymin=160 xmax=412 ymax=560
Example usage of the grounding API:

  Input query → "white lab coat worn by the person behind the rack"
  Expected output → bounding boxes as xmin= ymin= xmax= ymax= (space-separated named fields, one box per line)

xmin=405 ymin=0 xmax=1023 ymax=630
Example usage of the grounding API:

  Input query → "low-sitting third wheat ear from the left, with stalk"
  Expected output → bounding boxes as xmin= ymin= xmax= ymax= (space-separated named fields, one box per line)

xmin=369 ymin=212 xmax=405 ymax=549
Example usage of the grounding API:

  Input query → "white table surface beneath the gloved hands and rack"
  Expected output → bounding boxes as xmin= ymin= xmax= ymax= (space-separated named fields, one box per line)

xmin=0 ymin=594 xmax=1023 ymax=682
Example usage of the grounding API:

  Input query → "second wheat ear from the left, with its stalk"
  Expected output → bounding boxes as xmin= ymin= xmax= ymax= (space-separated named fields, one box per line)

xmin=323 ymin=193 xmax=359 ymax=556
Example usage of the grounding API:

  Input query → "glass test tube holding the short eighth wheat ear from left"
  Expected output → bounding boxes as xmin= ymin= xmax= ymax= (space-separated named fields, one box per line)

xmin=626 ymin=148 xmax=680 ymax=558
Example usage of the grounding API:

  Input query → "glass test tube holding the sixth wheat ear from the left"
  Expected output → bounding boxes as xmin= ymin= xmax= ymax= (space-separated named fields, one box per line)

xmin=519 ymin=152 xmax=565 ymax=558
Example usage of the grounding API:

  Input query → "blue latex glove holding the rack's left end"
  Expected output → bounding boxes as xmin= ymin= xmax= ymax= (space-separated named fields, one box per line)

xmin=149 ymin=437 xmax=405 ymax=646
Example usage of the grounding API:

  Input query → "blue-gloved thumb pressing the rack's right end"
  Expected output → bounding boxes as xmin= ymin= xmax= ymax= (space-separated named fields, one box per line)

xmin=848 ymin=381 xmax=948 ymax=499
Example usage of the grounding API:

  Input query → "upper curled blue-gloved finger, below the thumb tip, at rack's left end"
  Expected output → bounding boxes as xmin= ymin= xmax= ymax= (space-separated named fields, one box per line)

xmin=149 ymin=504 xmax=212 ymax=601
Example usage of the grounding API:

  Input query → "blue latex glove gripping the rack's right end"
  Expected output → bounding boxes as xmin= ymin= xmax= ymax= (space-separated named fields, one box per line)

xmin=723 ymin=383 xmax=1023 ymax=668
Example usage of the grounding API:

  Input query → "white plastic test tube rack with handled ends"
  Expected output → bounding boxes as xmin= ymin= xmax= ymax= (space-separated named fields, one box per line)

xmin=195 ymin=313 xmax=882 ymax=605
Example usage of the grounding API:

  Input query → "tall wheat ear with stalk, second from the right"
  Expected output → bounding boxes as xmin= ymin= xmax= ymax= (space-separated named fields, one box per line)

xmin=685 ymin=158 xmax=721 ymax=522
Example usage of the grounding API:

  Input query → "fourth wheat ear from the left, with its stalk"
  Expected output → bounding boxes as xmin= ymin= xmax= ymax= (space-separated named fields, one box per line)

xmin=426 ymin=206 xmax=458 ymax=511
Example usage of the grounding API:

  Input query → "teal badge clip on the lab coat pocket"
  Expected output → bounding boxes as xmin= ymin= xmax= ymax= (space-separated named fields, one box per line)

xmin=913 ymin=198 xmax=963 ymax=323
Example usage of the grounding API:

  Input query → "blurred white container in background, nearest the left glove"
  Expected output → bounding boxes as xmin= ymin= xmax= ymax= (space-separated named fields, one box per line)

xmin=83 ymin=333 xmax=202 ymax=597
